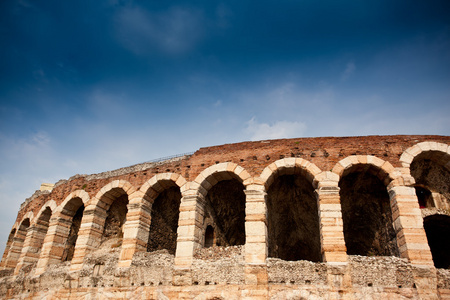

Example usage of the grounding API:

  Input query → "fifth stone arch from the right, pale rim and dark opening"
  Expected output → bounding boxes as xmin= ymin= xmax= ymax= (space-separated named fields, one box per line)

xmin=140 ymin=173 xmax=186 ymax=254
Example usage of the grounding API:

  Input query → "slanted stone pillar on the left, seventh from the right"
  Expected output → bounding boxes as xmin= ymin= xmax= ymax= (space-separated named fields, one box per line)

xmin=35 ymin=213 xmax=72 ymax=275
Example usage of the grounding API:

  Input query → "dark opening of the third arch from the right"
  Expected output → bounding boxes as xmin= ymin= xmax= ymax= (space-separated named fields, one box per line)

xmin=267 ymin=175 xmax=322 ymax=262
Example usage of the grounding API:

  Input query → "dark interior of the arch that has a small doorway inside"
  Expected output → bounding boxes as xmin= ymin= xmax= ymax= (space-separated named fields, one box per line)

xmin=205 ymin=179 xmax=245 ymax=246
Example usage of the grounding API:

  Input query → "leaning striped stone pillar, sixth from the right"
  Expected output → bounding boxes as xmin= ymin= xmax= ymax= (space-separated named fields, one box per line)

xmin=70 ymin=201 xmax=107 ymax=272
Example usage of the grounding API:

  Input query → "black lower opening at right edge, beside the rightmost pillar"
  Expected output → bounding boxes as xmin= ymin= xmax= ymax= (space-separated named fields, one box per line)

xmin=423 ymin=215 xmax=450 ymax=269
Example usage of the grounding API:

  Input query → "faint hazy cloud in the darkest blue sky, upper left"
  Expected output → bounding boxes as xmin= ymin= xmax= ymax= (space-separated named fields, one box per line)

xmin=116 ymin=6 xmax=202 ymax=55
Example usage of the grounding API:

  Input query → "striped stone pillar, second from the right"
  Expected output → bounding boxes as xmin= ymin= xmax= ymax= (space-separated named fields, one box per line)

xmin=316 ymin=186 xmax=347 ymax=263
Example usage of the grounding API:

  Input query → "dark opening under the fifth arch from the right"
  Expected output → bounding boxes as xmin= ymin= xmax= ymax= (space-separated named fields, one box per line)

xmin=147 ymin=186 xmax=181 ymax=254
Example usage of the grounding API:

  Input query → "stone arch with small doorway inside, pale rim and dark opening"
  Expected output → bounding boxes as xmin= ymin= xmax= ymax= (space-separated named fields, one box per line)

xmin=191 ymin=162 xmax=251 ymax=246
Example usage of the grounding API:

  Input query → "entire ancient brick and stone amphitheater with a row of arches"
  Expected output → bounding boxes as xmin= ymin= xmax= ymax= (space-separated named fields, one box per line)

xmin=0 ymin=135 xmax=450 ymax=299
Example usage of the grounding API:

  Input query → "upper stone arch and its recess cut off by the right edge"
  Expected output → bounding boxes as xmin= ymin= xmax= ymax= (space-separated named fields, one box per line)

xmin=400 ymin=142 xmax=450 ymax=209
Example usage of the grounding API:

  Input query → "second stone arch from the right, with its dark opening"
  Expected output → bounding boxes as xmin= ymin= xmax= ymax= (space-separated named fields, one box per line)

xmin=332 ymin=155 xmax=399 ymax=256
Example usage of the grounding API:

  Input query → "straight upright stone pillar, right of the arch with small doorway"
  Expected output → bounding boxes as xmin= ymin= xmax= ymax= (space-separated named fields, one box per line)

xmin=245 ymin=185 xmax=268 ymax=285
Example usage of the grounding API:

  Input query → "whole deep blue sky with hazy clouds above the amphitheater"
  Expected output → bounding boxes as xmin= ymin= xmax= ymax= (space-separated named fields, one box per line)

xmin=0 ymin=0 xmax=450 ymax=253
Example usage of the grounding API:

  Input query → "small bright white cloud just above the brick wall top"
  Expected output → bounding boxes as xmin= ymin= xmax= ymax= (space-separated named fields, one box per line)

xmin=245 ymin=117 xmax=306 ymax=141
